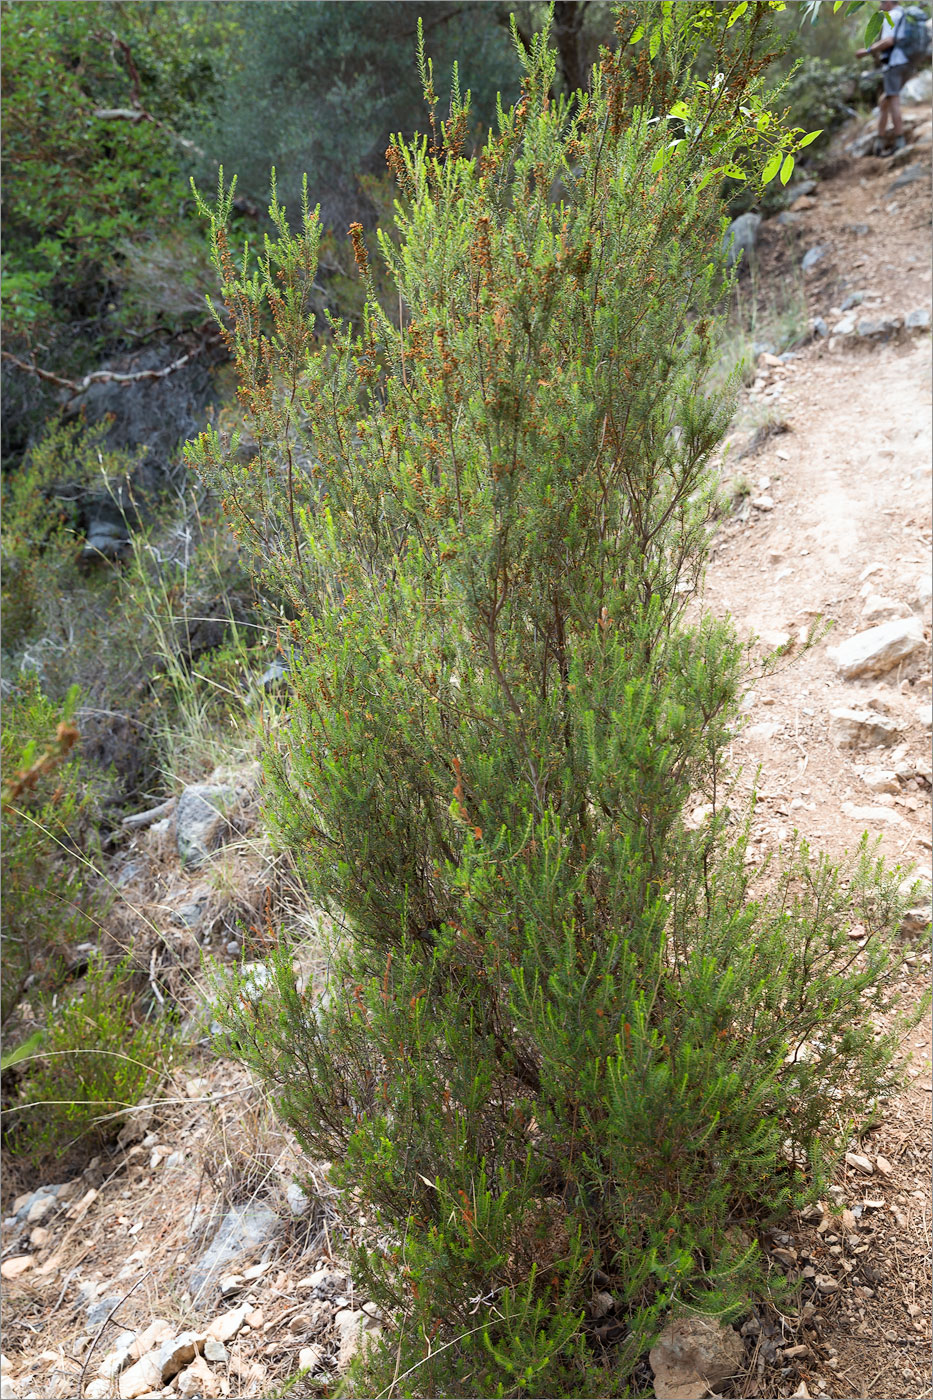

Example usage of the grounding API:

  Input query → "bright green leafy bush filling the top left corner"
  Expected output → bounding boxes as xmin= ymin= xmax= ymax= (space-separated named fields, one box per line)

xmin=0 ymin=0 xmax=224 ymax=336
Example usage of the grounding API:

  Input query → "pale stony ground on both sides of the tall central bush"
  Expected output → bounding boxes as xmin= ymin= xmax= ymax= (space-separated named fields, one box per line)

xmin=0 ymin=101 xmax=933 ymax=1400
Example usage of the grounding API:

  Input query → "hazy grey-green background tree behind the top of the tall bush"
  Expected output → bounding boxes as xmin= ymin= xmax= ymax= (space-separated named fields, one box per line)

xmin=191 ymin=0 xmax=518 ymax=234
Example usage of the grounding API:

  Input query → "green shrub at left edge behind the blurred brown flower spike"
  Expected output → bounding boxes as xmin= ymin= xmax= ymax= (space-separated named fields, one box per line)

xmin=0 ymin=678 xmax=104 ymax=1046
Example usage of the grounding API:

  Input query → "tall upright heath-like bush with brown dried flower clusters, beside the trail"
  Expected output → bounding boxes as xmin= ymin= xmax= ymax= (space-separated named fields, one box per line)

xmin=191 ymin=4 xmax=913 ymax=1396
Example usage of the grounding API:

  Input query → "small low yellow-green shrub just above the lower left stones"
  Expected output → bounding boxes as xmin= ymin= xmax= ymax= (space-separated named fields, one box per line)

xmin=6 ymin=958 xmax=171 ymax=1165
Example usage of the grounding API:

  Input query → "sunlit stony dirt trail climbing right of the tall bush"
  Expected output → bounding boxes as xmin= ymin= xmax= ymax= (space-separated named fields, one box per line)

xmin=703 ymin=133 xmax=933 ymax=1400
